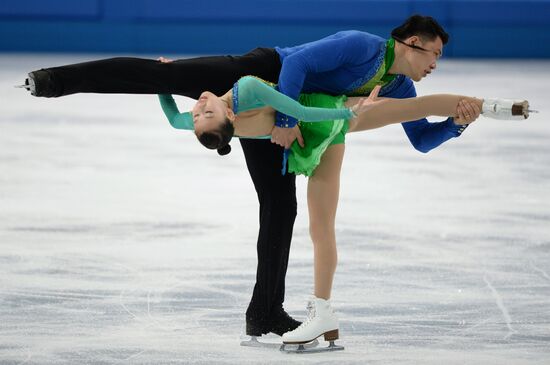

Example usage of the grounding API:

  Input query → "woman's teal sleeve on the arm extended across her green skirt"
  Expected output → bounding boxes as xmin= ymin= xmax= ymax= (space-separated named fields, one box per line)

xmin=239 ymin=76 xmax=353 ymax=122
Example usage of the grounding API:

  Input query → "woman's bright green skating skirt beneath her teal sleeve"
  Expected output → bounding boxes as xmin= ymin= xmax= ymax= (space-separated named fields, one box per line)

xmin=288 ymin=94 xmax=349 ymax=176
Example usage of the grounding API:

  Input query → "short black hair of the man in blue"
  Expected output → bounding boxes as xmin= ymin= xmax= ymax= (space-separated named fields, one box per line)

xmin=391 ymin=14 xmax=449 ymax=44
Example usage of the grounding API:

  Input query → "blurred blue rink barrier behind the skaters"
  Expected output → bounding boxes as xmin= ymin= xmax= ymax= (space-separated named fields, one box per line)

xmin=0 ymin=0 xmax=550 ymax=58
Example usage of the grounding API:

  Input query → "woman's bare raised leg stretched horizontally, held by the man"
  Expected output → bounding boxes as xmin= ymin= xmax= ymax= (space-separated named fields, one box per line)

xmin=346 ymin=94 xmax=483 ymax=132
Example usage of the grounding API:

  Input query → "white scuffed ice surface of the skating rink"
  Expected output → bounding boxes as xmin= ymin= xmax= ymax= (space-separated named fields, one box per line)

xmin=0 ymin=54 xmax=550 ymax=365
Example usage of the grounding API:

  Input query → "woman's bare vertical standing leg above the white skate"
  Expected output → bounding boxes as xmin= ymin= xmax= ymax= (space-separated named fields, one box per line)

xmin=307 ymin=144 xmax=345 ymax=299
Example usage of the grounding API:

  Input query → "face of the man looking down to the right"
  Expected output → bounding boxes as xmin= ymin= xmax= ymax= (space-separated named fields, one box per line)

xmin=406 ymin=36 xmax=443 ymax=81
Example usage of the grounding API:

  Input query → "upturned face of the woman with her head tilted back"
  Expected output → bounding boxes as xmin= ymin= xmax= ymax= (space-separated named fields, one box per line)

xmin=192 ymin=91 xmax=228 ymax=136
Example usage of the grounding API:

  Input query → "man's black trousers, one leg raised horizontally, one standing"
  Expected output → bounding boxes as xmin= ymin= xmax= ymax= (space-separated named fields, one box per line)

xmin=42 ymin=48 xmax=296 ymax=322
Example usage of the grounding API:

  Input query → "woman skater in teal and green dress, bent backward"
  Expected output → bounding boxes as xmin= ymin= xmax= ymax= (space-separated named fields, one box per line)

xmin=159 ymin=72 xmax=529 ymax=345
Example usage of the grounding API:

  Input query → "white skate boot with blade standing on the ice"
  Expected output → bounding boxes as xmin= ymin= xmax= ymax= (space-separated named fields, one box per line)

xmin=281 ymin=297 xmax=344 ymax=352
